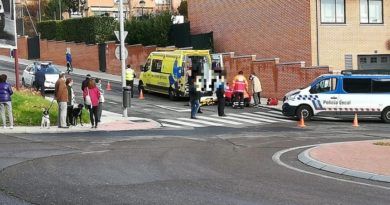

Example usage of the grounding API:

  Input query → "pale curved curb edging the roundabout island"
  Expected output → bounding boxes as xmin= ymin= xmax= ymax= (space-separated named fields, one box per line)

xmin=298 ymin=147 xmax=390 ymax=183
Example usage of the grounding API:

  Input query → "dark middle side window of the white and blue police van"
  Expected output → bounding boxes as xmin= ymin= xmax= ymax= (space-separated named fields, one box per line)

xmin=343 ymin=78 xmax=371 ymax=93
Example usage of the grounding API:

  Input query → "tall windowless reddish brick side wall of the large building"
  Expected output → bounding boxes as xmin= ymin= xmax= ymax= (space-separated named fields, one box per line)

xmin=188 ymin=0 xmax=312 ymax=65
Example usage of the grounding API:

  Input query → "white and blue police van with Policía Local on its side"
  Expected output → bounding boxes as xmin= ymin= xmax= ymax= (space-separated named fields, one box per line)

xmin=283 ymin=74 xmax=390 ymax=123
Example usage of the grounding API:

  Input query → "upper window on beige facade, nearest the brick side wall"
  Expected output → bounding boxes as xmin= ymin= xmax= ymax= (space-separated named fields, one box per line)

xmin=321 ymin=0 xmax=345 ymax=23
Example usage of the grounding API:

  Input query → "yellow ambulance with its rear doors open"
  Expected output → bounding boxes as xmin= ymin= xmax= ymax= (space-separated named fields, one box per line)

xmin=138 ymin=50 xmax=223 ymax=100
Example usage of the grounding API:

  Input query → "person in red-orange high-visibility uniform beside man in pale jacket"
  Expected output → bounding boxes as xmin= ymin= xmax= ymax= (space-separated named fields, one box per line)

xmin=233 ymin=71 xmax=248 ymax=109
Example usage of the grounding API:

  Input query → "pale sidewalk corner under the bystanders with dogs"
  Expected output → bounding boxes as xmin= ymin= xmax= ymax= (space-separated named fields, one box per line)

xmin=0 ymin=110 xmax=161 ymax=134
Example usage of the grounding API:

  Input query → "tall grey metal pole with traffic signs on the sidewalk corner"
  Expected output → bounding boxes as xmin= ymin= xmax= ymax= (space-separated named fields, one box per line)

xmin=119 ymin=0 xmax=127 ymax=117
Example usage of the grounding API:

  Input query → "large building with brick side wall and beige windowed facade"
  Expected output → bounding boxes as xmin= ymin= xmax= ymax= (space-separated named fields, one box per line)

xmin=188 ymin=0 xmax=390 ymax=70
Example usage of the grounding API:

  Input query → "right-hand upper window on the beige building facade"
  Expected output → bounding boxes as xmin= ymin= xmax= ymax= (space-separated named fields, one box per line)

xmin=360 ymin=0 xmax=383 ymax=24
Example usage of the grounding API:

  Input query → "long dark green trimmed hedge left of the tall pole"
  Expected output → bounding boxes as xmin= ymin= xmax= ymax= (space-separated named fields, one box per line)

xmin=38 ymin=16 xmax=117 ymax=44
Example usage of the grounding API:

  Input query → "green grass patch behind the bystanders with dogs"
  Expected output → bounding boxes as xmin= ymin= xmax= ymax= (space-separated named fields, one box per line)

xmin=12 ymin=89 xmax=90 ymax=126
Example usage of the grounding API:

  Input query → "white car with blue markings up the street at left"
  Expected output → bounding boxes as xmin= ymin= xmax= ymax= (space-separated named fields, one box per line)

xmin=22 ymin=62 xmax=61 ymax=90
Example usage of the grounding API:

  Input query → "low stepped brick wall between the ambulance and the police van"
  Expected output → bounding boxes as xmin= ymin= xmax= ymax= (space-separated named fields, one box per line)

xmin=223 ymin=53 xmax=329 ymax=99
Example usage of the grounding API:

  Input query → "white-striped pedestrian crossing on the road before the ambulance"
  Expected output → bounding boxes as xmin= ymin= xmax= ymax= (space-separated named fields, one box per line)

xmin=159 ymin=111 xmax=295 ymax=129
